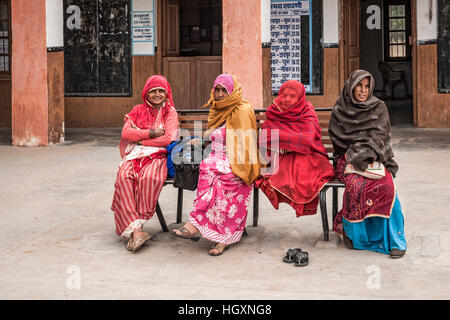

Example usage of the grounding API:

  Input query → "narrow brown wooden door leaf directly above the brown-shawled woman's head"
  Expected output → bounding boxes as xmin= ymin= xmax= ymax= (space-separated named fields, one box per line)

xmin=341 ymin=0 xmax=361 ymax=86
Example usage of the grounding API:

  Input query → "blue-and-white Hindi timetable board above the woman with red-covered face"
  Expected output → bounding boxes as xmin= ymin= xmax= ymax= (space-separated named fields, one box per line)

xmin=270 ymin=0 xmax=313 ymax=94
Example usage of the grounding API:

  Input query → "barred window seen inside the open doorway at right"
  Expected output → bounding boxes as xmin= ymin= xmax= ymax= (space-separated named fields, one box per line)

xmin=384 ymin=1 xmax=411 ymax=61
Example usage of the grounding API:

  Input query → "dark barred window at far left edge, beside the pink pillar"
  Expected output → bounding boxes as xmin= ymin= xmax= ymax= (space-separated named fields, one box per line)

xmin=0 ymin=0 xmax=11 ymax=75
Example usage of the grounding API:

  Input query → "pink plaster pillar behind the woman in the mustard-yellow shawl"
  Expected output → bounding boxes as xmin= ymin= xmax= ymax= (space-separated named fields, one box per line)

xmin=222 ymin=0 xmax=263 ymax=108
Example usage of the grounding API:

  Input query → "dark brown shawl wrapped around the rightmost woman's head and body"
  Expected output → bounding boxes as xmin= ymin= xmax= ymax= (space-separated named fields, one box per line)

xmin=329 ymin=70 xmax=398 ymax=176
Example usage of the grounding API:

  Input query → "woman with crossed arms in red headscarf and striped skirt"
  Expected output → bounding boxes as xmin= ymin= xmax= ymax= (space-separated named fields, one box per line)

xmin=111 ymin=75 xmax=178 ymax=251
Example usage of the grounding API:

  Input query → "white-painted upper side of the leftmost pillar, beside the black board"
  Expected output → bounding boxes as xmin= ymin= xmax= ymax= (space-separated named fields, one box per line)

xmin=46 ymin=0 xmax=64 ymax=48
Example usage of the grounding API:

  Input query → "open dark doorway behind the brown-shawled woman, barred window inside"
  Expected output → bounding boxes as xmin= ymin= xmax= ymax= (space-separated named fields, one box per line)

xmin=359 ymin=0 xmax=413 ymax=125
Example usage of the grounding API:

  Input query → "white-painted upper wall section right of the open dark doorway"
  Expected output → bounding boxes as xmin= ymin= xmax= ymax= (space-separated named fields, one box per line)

xmin=417 ymin=0 xmax=437 ymax=41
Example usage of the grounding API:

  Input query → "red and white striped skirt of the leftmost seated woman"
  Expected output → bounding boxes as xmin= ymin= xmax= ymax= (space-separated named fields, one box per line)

xmin=111 ymin=158 xmax=167 ymax=239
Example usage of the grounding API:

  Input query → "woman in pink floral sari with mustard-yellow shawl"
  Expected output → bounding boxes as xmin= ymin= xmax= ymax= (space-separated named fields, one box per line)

xmin=173 ymin=74 xmax=259 ymax=256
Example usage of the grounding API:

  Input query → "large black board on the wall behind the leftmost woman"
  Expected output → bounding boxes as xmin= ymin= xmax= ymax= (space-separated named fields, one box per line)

xmin=63 ymin=0 xmax=131 ymax=96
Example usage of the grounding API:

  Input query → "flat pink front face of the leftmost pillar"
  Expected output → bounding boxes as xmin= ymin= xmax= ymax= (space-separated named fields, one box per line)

xmin=11 ymin=0 xmax=48 ymax=146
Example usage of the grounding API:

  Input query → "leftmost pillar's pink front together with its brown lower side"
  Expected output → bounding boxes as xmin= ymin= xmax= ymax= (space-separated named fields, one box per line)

xmin=11 ymin=0 xmax=64 ymax=146
